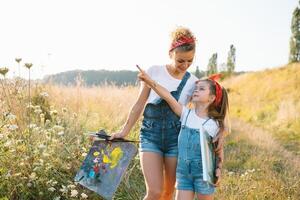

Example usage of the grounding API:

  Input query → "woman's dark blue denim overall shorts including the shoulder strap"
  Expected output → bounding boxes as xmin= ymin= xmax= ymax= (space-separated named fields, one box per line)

xmin=140 ymin=72 xmax=191 ymax=157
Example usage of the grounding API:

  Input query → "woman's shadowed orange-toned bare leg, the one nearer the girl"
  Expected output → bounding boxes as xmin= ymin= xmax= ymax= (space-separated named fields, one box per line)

xmin=161 ymin=157 xmax=177 ymax=200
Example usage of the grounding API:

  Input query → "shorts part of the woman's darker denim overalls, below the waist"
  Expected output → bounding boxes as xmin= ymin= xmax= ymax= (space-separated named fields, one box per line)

xmin=140 ymin=118 xmax=181 ymax=157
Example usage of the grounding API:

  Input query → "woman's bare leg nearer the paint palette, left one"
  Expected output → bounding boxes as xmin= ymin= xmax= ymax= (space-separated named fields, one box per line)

xmin=140 ymin=152 xmax=164 ymax=200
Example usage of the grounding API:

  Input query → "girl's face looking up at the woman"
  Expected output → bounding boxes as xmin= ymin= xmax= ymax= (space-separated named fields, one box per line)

xmin=192 ymin=81 xmax=215 ymax=104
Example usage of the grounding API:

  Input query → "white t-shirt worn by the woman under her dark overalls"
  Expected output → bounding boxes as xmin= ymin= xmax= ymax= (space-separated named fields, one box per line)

xmin=146 ymin=65 xmax=198 ymax=105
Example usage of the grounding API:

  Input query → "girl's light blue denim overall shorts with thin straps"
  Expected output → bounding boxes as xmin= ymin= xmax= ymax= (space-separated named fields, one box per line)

xmin=176 ymin=110 xmax=215 ymax=195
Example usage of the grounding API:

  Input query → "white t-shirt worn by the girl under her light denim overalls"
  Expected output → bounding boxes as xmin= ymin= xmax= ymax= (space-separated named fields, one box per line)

xmin=180 ymin=106 xmax=219 ymax=137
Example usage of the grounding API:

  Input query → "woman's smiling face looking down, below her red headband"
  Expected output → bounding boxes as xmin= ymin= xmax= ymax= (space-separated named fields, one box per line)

xmin=169 ymin=50 xmax=195 ymax=73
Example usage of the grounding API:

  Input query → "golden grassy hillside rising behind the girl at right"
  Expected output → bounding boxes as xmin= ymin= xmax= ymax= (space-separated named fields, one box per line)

xmin=224 ymin=63 xmax=300 ymax=156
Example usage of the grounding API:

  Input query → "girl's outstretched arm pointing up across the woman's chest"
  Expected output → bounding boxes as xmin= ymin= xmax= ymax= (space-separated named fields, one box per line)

xmin=138 ymin=69 xmax=182 ymax=116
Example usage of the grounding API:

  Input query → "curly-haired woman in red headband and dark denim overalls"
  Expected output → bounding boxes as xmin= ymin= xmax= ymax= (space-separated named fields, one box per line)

xmin=111 ymin=27 xmax=223 ymax=200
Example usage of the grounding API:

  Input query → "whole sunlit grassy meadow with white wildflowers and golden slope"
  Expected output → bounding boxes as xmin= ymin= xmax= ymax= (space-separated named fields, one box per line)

xmin=0 ymin=65 xmax=300 ymax=200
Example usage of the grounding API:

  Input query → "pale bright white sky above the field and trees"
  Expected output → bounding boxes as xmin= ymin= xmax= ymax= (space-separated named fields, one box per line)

xmin=0 ymin=0 xmax=298 ymax=78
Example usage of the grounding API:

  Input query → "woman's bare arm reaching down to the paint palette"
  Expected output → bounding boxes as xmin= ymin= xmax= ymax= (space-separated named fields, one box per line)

xmin=110 ymin=83 xmax=150 ymax=140
